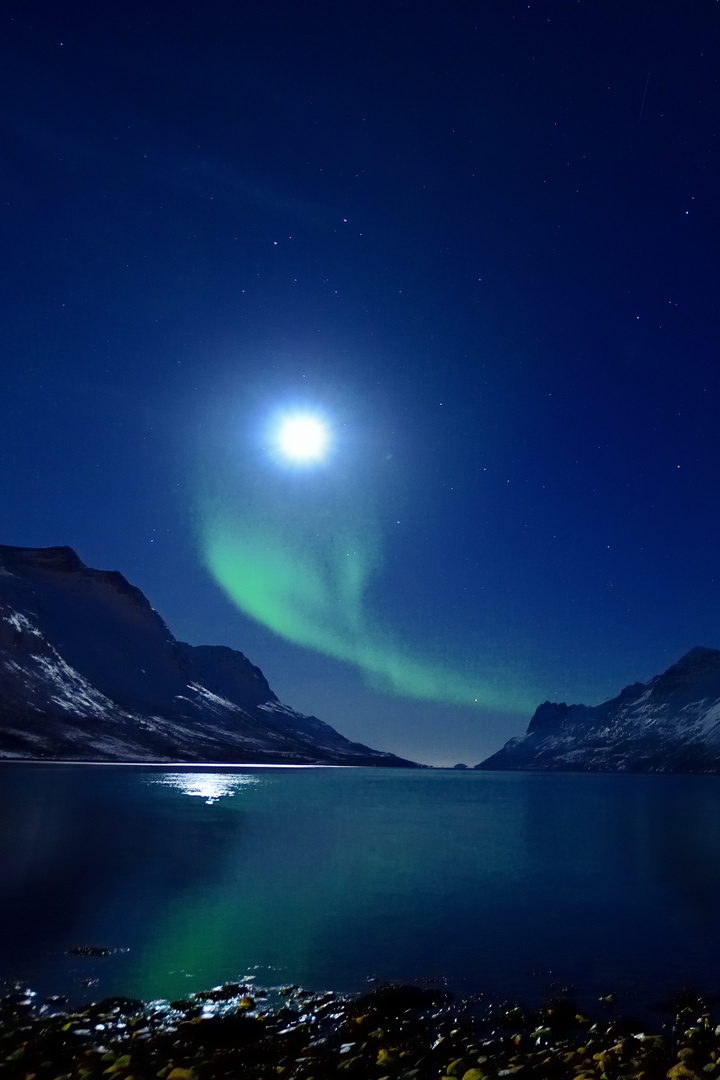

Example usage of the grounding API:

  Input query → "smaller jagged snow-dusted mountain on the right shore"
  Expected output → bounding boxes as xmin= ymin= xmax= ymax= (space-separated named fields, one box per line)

xmin=475 ymin=647 xmax=720 ymax=772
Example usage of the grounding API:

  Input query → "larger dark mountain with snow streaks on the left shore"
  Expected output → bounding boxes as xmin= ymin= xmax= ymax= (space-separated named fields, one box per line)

xmin=0 ymin=545 xmax=413 ymax=766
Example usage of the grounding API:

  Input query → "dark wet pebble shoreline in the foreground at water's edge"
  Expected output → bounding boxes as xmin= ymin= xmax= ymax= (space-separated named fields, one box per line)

xmin=0 ymin=984 xmax=720 ymax=1080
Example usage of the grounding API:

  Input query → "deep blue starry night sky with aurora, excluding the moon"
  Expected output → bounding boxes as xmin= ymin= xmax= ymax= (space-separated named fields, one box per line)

xmin=0 ymin=0 xmax=720 ymax=765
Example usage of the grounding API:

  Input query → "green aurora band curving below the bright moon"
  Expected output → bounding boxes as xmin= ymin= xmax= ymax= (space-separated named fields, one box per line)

xmin=198 ymin=425 xmax=530 ymax=712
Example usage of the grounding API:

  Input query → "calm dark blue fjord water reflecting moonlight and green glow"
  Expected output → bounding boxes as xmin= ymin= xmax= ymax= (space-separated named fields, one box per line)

xmin=0 ymin=764 xmax=720 ymax=1003
